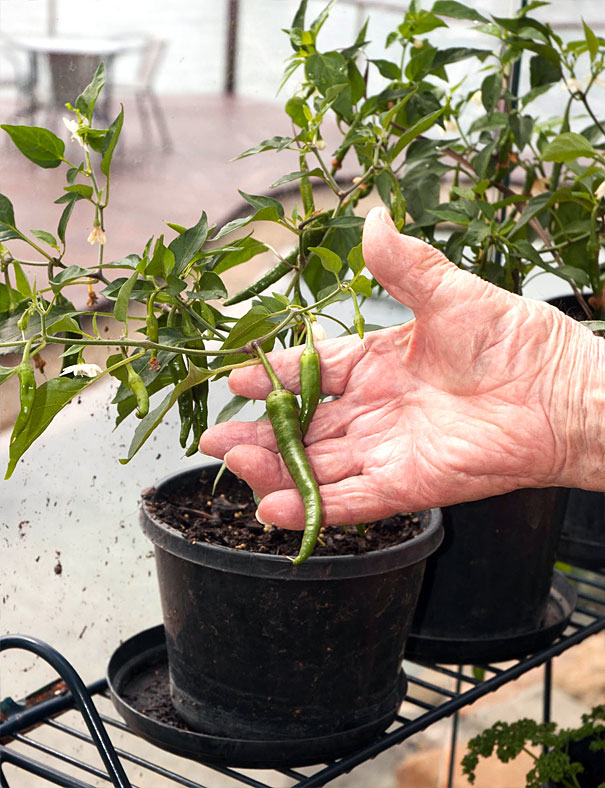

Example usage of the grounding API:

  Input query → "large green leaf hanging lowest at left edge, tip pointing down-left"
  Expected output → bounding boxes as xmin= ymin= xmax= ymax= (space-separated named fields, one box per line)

xmin=4 ymin=377 xmax=89 ymax=479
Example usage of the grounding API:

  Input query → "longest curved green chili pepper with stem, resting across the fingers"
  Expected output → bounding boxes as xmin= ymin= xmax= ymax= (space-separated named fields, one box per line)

xmin=253 ymin=344 xmax=322 ymax=564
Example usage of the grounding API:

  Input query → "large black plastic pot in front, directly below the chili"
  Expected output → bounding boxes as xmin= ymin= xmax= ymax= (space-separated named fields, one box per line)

xmin=136 ymin=464 xmax=442 ymax=762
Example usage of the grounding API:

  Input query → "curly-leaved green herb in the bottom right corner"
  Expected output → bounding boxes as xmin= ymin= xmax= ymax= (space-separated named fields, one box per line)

xmin=462 ymin=706 xmax=605 ymax=788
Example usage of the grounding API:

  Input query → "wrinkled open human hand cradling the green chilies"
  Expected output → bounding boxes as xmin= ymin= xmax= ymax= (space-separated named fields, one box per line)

xmin=200 ymin=208 xmax=605 ymax=528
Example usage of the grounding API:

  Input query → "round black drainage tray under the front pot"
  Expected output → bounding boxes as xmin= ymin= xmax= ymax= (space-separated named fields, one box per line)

xmin=107 ymin=625 xmax=405 ymax=769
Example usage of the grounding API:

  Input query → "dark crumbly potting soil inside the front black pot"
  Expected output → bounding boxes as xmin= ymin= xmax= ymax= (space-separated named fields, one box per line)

xmin=142 ymin=469 xmax=422 ymax=556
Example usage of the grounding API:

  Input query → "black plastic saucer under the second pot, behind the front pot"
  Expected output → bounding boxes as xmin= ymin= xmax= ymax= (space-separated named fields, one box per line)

xmin=405 ymin=571 xmax=578 ymax=665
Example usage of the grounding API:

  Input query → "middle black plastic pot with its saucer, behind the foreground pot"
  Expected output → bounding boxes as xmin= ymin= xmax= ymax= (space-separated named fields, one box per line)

xmin=406 ymin=488 xmax=572 ymax=663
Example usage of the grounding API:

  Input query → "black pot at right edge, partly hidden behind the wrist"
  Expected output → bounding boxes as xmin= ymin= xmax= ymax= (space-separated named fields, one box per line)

xmin=549 ymin=295 xmax=605 ymax=569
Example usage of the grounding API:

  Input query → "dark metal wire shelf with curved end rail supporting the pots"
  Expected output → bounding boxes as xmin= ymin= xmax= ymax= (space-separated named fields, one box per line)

xmin=0 ymin=571 xmax=605 ymax=788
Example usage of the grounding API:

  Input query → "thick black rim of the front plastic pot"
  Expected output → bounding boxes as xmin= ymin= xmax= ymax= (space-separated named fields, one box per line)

xmin=140 ymin=463 xmax=443 ymax=580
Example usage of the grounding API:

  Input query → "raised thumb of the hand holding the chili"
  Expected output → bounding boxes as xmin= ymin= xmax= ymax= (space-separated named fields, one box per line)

xmin=363 ymin=208 xmax=466 ymax=315
